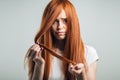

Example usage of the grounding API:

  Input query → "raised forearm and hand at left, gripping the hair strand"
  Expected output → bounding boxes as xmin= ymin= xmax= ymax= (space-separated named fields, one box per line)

xmin=28 ymin=44 xmax=45 ymax=80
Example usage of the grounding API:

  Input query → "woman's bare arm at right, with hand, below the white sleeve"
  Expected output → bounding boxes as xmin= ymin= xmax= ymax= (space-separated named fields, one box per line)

xmin=69 ymin=61 xmax=97 ymax=80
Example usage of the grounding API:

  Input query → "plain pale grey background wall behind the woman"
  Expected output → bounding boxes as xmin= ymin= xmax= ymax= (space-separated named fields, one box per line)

xmin=0 ymin=0 xmax=120 ymax=80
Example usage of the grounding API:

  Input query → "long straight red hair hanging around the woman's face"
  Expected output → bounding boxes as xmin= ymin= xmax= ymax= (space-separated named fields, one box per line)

xmin=24 ymin=0 xmax=86 ymax=80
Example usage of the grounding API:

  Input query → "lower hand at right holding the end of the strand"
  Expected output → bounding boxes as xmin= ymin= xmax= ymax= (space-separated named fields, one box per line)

xmin=68 ymin=63 xmax=84 ymax=75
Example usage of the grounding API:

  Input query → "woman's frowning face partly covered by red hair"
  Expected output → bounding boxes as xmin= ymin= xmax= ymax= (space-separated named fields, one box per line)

xmin=52 ymin=10 xmax=67 ymax=40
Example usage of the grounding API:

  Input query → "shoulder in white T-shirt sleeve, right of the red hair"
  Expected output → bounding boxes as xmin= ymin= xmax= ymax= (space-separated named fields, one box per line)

xmin=85 ymin=45 xmax=99 ymax=66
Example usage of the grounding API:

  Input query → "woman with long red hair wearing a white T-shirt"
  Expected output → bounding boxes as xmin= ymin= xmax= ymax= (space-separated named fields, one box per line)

xmin=25 ymin=0 xmax=98 ymax=80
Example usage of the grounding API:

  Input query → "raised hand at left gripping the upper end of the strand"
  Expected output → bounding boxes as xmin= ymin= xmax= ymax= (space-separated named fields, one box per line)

xmin=28 ymin=44 xmax=45 ymax=64
